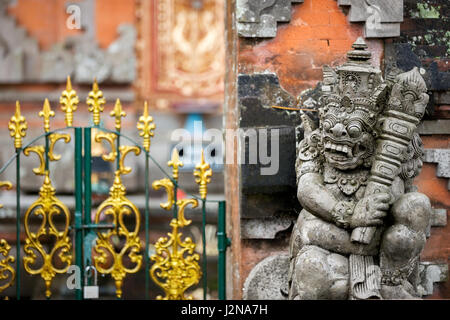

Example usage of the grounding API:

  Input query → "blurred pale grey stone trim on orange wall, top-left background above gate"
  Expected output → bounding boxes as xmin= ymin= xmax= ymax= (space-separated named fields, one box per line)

xmin=0 ymin=0 xmax=136 ymax=83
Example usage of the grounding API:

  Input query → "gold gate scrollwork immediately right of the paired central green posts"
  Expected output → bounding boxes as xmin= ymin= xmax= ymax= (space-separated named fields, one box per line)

xmin=94 ymin=146 xmax=142 ymax=298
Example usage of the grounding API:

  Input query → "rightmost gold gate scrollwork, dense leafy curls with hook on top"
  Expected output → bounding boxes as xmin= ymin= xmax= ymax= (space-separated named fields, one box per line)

xmin=150 ymin=199 xmax=202 ymax=300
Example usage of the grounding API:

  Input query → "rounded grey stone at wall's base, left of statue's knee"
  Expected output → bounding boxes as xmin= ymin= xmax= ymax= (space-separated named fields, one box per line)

xmin=243 ymin=253 xmax=289 ymax=300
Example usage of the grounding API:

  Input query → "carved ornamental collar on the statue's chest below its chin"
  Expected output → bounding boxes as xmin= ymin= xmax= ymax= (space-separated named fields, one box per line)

xmin=324 ymin=166 xmax=370 ymax=200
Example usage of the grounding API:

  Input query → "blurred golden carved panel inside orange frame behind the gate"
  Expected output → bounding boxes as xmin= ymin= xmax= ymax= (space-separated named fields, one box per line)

xmin=155 ymin=0 xmax=225 ymax=97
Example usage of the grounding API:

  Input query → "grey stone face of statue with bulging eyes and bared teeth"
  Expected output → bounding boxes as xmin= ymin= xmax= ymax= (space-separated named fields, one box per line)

xmin=320 ymin=97 xmax=375 ymax=170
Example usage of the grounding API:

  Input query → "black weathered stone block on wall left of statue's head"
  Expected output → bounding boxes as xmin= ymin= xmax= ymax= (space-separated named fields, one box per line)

xmin=238 ymin=73 xmax=303 ymax=218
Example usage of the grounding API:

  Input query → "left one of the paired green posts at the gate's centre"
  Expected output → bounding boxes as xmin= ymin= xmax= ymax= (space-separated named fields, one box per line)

xmin=75 ymin=128 xmax=84 ymax=300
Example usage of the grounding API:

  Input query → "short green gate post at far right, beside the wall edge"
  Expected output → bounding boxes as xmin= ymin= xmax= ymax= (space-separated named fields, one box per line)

xmin=217 ymin=201 xmax=230 ymax=300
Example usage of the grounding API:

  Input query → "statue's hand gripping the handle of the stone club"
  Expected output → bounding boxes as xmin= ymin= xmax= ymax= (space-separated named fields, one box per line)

xmin=350 ymin=193 xmax=390 ymax=229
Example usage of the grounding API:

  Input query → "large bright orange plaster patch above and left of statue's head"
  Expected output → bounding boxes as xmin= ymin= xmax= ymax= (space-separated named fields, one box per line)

xmin=238 ymin=0 xmax=383 ymax=95
